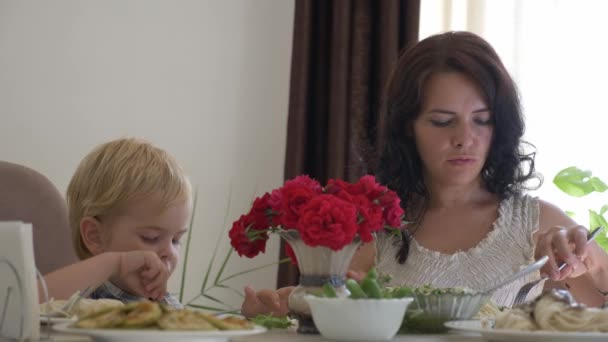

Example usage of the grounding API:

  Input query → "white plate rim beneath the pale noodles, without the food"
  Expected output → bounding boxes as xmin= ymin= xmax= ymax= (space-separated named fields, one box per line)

xmin=445 ymin=321 xmax=608 ymax=342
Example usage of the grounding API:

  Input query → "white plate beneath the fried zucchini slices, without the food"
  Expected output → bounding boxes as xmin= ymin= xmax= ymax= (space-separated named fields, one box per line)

xmin=53 ymin=322 xmax=266 ymax=342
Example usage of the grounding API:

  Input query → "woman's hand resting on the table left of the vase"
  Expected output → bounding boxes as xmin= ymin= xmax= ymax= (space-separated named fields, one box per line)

xmin=241 ymin=286 xmax=294 ymax=317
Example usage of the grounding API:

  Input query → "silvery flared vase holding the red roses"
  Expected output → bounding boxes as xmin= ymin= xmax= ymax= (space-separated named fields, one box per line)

xmin=279 ymin=230 xmax=361 ymax=334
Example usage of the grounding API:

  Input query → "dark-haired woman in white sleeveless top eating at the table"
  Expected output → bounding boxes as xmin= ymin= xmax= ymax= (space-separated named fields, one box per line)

xmin=242 ymin=32 xmax=608 ymax=315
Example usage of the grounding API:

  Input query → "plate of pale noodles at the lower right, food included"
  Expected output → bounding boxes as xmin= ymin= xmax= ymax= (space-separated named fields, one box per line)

xmin=445 ymin=290 xmax=608 ymax=342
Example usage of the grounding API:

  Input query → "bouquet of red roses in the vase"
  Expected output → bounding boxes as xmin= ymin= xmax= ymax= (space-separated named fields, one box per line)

xmin=229 ymin=175 xmax=404 ymax=260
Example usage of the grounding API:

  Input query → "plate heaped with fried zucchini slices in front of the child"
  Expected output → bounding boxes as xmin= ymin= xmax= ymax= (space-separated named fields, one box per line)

xmin=53 ymin=301 xmax=266 ymax=342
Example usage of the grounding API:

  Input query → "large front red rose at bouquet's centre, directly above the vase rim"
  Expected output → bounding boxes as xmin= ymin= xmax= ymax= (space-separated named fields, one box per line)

xmin=296 ymin=194 xmax=358 ymax=250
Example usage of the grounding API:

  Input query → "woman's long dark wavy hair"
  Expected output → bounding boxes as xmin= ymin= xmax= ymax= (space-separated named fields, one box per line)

xmin=376 ymin=32 xmax=542 ymax=263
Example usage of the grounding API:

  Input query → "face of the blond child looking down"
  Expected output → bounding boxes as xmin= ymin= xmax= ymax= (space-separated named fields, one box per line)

xmin=102 ymin=196 xmax=190 ymax=273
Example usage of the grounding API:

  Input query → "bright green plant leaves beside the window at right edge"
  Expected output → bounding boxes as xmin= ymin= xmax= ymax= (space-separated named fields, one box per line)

xmin=553 ymin=166 xmax=608 ymax=251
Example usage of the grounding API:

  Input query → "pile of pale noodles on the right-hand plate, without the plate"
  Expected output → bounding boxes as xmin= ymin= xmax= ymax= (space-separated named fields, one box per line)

xmin=494 ymin=289 xmax=608 ymax=332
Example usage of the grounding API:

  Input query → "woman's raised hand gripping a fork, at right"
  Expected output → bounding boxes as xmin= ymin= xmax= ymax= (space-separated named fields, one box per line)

xmin=535 ymin=225 xmax=589 ymax=281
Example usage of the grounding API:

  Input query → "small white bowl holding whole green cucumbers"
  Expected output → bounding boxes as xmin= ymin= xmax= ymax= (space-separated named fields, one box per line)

xmin=304 ymin=295 xmax=413 ymax=341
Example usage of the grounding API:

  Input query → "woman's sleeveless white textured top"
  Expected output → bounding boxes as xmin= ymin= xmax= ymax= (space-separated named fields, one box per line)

xmin=376 ymin=196 xmax=542 ymax=306
